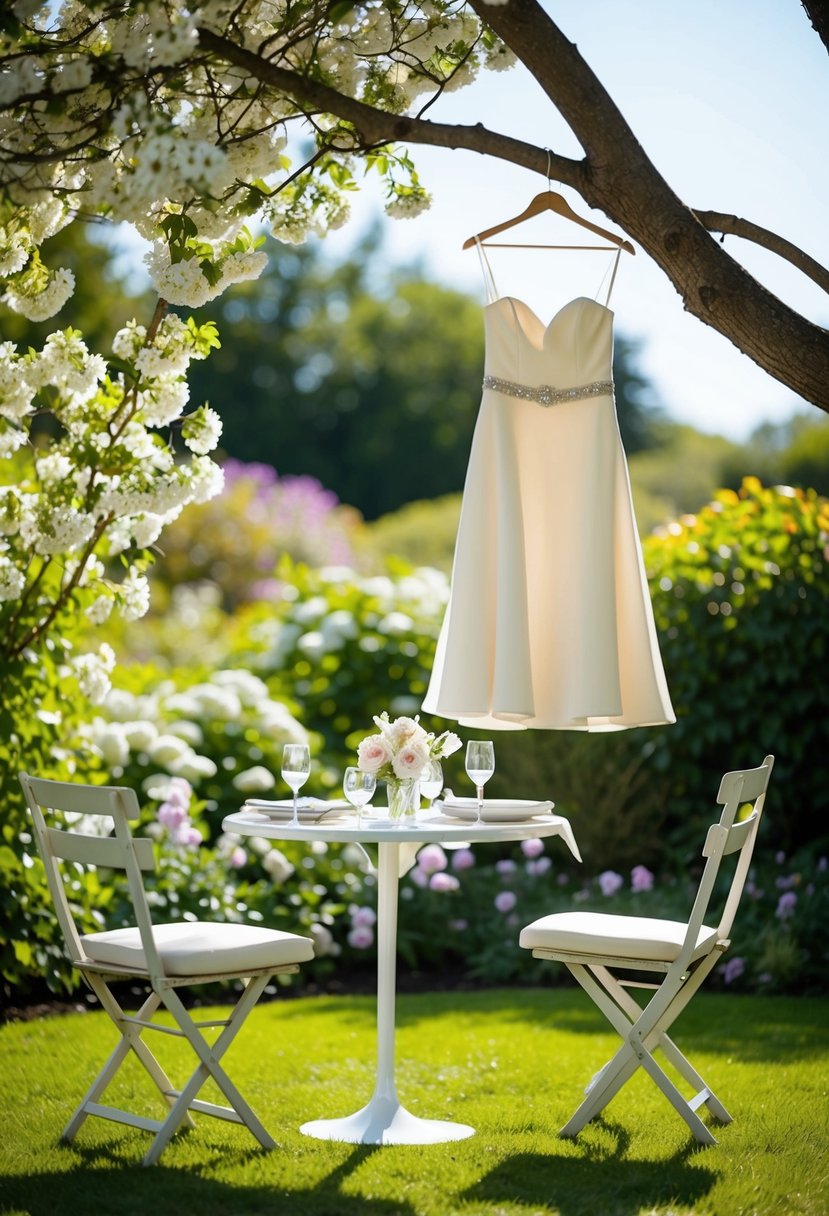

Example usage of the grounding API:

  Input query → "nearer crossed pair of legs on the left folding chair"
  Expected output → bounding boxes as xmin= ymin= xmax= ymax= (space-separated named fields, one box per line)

xmin=141 ymin=975 xmax=276 ymax=1165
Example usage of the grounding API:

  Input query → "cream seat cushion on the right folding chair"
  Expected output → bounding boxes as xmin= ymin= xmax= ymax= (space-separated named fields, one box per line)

xmin=519 ymin=912 xmax=717 ymax=963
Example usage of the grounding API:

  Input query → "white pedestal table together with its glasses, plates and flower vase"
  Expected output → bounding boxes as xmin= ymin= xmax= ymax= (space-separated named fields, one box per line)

xmin=222 ymin=713 xmax=581 ymax=1144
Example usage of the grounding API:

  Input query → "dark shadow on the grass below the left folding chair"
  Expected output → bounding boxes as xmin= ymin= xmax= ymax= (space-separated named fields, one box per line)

xmin=0 ymin=1143 xmax=417 ymax=1216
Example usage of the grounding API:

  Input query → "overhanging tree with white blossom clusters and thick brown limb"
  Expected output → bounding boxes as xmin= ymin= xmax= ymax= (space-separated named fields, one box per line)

xmin=0 ymin=0 xmax=829 ymax=710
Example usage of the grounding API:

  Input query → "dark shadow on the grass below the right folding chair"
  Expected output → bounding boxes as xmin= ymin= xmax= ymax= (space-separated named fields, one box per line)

xmin=457 ymin=1133 xmax=720 ymax=1216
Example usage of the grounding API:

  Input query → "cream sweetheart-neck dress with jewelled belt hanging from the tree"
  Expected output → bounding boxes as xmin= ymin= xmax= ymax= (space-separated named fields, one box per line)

xmin=423 ymin=244 xmax=675 ymax=731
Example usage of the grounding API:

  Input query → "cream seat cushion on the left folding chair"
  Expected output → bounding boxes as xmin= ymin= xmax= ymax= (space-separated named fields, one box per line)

xmin=80 ymin=921 xmax=314 ymax=975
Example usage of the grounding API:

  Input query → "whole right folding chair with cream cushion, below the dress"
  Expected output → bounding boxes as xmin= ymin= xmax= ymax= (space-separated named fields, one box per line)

xmin=519 ymin=756 xmax=774 ymax=1144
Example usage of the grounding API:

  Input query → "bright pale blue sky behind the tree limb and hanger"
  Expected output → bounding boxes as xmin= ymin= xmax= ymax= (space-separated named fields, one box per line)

xmin=326 ymin=0 xmax=829 ymax=439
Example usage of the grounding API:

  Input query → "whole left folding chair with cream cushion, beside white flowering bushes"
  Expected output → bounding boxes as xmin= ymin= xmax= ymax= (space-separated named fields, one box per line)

xmin=19 ymin=773 xmax=314 ymax=1165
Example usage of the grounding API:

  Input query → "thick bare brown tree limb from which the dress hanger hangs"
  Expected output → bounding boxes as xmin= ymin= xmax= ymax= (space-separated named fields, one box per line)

xmin=199 ymin=0 xmax=829 ymax=412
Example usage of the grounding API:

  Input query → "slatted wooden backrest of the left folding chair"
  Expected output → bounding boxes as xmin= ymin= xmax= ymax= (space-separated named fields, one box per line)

xmin=19 ymin=772 xmax=163 ymax=975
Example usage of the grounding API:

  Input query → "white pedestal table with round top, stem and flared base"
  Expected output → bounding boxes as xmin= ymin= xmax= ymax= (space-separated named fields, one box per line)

xmin=222 ymin=807 xmax=581 ymax=1144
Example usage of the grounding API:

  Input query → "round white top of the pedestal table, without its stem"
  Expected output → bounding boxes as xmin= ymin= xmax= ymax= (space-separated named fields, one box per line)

xmin=222 ymin=806 xmax=581 ymax=861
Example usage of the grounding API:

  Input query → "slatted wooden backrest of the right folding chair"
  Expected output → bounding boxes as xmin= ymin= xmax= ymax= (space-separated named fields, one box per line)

xmin=677 ymin=756 xmax=774 ymax=966
